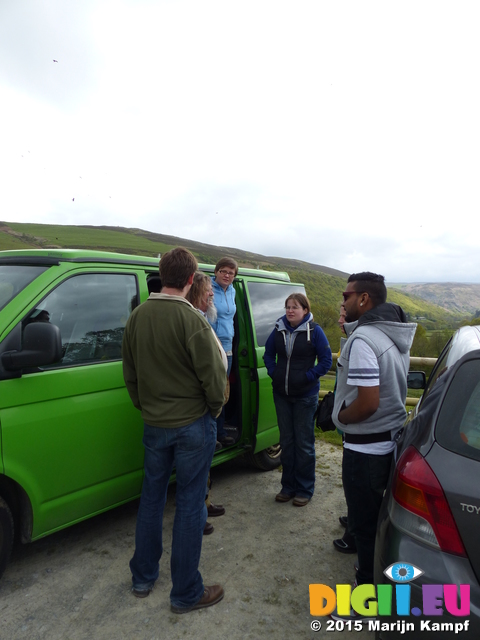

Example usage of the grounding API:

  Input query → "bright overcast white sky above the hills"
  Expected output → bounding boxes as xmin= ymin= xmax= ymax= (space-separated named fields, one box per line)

xmin=0 ymin=0 xmax=480 ymax=284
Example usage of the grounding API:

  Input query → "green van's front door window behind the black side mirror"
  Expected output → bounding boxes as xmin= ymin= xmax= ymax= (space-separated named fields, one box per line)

xmin=23 ymin=273 xmax=138 ymax=369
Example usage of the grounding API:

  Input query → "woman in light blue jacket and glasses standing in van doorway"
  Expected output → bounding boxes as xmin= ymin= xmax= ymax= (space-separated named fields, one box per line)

xmin=210 ymin=257 xmax=238 ymax=449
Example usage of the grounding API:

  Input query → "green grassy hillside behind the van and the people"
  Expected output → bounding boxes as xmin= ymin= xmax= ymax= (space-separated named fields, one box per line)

xmin=0 ymin=222 xmax=464 ymax=349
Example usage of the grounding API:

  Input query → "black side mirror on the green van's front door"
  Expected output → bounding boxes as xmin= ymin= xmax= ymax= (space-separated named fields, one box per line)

xmin=2 ymin=322 xmax=62 ymax=371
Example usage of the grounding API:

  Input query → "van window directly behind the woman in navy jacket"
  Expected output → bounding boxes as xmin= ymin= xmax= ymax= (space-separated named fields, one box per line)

xmin=247 ymin=282 xmax=305 ymax=347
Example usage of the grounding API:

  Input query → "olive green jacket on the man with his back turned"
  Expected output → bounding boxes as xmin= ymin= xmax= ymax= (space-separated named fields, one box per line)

xmin=122 ymin=293 xmax=225 ymax=427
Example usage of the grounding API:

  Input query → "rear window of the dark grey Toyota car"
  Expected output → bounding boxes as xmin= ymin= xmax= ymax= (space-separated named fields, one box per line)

xmin=436 ymin=360 xmax=480 ymax=460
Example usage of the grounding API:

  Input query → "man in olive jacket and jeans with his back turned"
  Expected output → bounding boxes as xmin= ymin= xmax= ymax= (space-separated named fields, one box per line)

xmin=122 ymin=247 xmax=229 ymax=613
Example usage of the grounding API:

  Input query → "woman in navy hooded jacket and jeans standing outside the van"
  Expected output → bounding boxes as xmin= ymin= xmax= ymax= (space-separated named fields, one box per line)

xmin=263 ymin=293 xmax=332 ymax=507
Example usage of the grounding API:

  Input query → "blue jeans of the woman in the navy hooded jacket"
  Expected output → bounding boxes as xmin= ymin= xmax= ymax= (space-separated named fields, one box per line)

xmin=273 ymin=391 xmax=318 ymax=498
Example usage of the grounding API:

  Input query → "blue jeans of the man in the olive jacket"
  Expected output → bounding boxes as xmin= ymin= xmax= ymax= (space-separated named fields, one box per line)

xmin=130 ymin=412 xmax=216 ymax=607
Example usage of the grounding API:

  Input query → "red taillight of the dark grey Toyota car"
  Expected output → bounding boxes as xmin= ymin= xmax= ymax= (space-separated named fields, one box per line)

xmin=392 ymin=447 xmax=467 ymax=556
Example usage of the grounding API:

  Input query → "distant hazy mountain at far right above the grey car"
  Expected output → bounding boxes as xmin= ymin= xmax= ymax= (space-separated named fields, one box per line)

xmin=392 ymin=282 xmax=480 ymax=315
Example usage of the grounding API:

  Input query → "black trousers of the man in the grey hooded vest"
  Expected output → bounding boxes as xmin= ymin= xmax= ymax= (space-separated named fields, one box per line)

xmin=342 ymin=448 xmax=393 ymax=584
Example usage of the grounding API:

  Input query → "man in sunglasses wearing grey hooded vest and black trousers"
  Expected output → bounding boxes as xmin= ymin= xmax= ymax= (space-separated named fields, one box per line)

xmin=333 ymin=271 xmax=416 ymax=612
